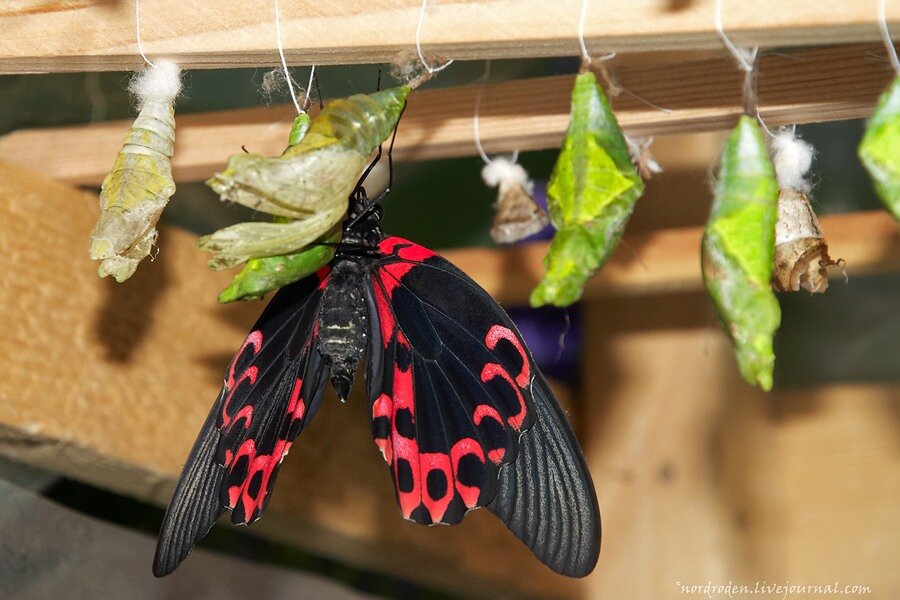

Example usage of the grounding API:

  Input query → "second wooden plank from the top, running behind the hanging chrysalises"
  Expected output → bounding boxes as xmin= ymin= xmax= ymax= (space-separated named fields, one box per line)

xmin=0 ymin=45 xmax=892 ymax=185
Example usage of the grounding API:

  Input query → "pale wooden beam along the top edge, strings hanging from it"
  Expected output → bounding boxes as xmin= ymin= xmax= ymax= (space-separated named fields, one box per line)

xmin=0 ymin=0 xmax=900 ymax=73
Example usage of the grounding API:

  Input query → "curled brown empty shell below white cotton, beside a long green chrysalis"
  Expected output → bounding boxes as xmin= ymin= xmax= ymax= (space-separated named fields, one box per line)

xmin=772 ymin=188 xmax=843 ymax=294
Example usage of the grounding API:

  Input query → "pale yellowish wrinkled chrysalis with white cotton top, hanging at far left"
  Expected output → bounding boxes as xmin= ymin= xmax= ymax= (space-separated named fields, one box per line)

xmin=90 ymin=60 xmax=181 ymax=282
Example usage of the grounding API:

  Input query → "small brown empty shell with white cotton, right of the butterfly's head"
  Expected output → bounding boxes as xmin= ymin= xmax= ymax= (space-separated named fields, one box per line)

xmin=481 ymin=157 xmax=549 ymax=244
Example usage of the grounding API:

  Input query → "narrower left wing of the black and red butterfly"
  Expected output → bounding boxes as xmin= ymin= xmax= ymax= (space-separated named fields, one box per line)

xmin=153 ymin=267 xmax=329 ymax=577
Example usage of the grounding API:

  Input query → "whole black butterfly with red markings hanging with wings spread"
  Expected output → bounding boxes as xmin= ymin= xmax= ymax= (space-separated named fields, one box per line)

xmin=153 ymin=186 xmax=600 ymax=577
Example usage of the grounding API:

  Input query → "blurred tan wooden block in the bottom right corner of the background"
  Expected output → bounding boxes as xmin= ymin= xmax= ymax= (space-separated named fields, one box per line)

xmin=772 ymin=383 xmax=900 ymax=598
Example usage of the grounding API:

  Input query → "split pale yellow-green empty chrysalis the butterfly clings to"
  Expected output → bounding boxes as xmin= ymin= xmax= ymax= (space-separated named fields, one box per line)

xmin=200 ymin=85 xmax=410 ymax=269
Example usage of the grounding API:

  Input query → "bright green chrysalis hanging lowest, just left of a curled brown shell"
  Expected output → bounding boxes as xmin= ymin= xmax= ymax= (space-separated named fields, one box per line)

xmin=702 ymin=115 xmax=781 ymax=391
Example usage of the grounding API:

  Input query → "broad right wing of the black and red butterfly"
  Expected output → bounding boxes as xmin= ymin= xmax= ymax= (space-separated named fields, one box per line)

xmin=367 ymin=237 xmax=600 ymax=576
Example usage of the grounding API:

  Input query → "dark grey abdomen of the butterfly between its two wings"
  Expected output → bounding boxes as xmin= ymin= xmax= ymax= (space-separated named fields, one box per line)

xmin=318 ymin=260 xmax=368 ymax=401
